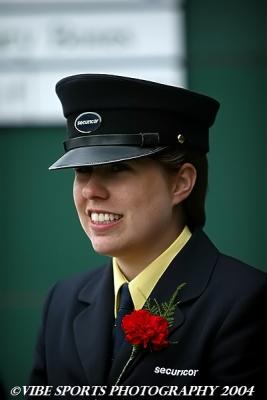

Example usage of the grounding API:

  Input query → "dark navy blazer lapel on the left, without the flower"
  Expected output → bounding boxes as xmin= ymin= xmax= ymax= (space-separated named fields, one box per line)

xmin=74 ymin=267 xmax=114 ymax=385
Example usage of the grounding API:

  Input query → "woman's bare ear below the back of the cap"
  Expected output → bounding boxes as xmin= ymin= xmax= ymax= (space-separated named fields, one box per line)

xmin=172 ymin=163 xmax=197 ymax=205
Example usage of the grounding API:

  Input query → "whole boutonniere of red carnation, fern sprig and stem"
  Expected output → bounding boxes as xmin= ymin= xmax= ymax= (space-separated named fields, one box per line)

xmin=115 ymin=283 xmax=186 ymax=386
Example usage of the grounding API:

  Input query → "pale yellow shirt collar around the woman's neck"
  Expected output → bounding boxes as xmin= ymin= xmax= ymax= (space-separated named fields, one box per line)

xmin=112 ymin=226 xmax=191 ymax=317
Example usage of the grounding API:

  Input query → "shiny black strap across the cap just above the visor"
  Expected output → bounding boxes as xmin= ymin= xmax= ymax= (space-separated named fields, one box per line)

xmin=64 ymin=133 xmax=161 ymax=152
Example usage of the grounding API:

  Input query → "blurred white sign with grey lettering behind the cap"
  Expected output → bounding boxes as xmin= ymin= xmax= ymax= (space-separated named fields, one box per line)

xmin=0 ymin=0 xmax=185 ymax=125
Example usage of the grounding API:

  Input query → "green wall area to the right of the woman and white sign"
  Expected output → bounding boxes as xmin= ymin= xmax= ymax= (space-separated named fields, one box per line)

xmin=187 ymin=0 xmax=267 ymax=268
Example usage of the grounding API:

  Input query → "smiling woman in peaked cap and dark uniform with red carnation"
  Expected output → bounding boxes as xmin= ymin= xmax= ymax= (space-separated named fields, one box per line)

xmin=28 ymin=74 xmax=267 ymax=399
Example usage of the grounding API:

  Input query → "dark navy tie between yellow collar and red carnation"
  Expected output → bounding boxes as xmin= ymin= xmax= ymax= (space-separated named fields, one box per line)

xmin=113 ymin=283 xmax=134 ymax=359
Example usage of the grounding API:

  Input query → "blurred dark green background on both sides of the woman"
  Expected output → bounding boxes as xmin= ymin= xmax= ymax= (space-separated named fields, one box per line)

xmin=0 ymin=0 xmax=267 ymax=396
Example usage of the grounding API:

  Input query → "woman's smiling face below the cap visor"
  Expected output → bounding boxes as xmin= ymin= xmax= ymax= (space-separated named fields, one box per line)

xmin=73 ymin=158 xmax=186 ymax=259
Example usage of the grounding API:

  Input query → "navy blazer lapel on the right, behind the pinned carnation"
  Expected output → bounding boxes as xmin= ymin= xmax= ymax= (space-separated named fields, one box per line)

xmin=108 ymin=230 xmax=219 ymax=385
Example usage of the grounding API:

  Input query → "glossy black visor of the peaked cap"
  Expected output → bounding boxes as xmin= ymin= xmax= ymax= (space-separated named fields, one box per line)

xmin=49 ymin=146 xmax=166 ymax=170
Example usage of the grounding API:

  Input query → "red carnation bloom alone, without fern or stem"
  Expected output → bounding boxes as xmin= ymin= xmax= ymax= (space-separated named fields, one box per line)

xmin=121 ymin=310 xmax=169 ymax=350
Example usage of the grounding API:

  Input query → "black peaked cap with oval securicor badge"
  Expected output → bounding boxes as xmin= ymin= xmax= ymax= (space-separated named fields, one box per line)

xmin=50 ymin=74 xmax=219 ymax=169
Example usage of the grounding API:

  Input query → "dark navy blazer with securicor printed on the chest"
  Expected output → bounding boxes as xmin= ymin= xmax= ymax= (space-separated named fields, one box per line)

xmin=30 ymin=230 xmax=267 ymax=399
